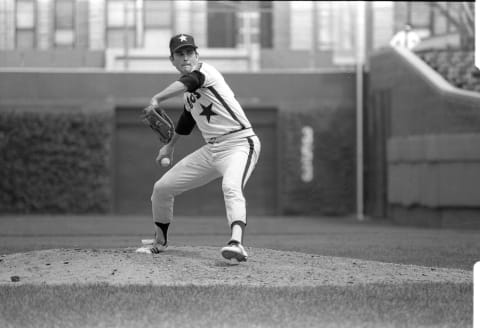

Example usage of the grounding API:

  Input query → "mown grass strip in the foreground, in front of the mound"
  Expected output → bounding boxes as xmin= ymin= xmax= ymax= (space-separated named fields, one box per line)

xmin=0 ymin=283 xmax=473 ymax=328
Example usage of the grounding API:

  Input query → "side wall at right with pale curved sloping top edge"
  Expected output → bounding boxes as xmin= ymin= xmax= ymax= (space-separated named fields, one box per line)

xmin=368 ymin=48 xmax=480 ymax=226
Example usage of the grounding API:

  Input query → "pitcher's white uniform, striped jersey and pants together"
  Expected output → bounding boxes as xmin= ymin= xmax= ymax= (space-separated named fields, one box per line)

xmin=151 ymin=59 xmax=261 ymax=231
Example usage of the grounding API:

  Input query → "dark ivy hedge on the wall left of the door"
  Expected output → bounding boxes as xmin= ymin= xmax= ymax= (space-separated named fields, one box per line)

xmin=0 ymin=104 xmax=114 ymax=213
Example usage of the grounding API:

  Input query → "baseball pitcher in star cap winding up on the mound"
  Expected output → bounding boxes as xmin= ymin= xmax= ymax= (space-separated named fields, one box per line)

xmin=137 ymin=34 xmax=260 ymax=262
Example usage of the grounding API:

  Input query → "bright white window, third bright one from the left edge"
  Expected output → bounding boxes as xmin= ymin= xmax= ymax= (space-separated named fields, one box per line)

xmin=107 ymin=0 xmax=136 ymax=48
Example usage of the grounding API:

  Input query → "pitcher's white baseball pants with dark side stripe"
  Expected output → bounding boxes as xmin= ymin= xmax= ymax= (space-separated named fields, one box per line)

xmin=151 ymin=136 xmax=261 ymax=226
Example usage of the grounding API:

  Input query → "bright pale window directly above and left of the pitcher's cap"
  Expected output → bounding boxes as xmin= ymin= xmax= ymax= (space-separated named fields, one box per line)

xmin=143 ymin=0 xmax=173 ymax=49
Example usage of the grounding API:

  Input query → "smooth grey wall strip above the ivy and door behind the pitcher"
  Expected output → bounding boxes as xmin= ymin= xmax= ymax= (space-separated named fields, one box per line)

xmin=0 ymin=69 xmax=355 ymax=110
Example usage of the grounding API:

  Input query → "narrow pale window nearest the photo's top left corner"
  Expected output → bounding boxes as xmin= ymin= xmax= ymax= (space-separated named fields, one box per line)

xmin=15 ymin=0 xmax=35 ymax=49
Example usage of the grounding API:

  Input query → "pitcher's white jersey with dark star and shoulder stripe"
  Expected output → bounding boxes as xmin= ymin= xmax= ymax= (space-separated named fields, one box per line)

xmin=183 ymin=63 xmax=253 ymax=142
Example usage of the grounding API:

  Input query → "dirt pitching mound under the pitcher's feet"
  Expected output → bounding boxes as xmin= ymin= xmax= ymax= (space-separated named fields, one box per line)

xmin=0 ymin=246 xmax=472 ymax=287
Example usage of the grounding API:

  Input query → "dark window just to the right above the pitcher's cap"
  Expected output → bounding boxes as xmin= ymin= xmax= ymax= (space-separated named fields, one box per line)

xmin=207 ymin=1 xmax=238 ymax=48
